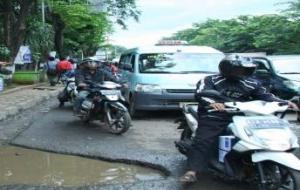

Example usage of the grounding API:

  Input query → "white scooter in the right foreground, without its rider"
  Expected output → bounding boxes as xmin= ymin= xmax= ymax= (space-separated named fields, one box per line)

xmin=175 ymin=91 xmax=300 ymax=190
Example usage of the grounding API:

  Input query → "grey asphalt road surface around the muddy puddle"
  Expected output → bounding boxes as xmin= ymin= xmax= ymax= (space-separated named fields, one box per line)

xmin=0 ymin=100 xmax=298 ymax=190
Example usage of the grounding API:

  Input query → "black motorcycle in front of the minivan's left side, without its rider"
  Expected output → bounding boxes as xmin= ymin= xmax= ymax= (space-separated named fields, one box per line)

xmin=80 ymin=81 xmax=131 ymax=134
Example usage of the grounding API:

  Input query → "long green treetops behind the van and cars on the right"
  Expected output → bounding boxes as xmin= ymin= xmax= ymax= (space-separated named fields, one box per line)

xmin=166 ymin=15 xmax=300 ymax=54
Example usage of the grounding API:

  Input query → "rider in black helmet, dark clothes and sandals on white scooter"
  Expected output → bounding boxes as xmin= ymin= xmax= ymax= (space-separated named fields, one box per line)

xmin=180 ymin=55 xmax=298 ymax=183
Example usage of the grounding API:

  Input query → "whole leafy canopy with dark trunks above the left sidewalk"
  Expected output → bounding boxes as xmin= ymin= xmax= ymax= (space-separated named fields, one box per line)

xmin=0 ymin=0 xmax=140 ymax=61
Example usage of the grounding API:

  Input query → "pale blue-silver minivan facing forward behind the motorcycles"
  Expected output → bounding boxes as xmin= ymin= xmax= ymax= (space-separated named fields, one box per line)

xmin=119 ymin=46 xmax=224 ymax=116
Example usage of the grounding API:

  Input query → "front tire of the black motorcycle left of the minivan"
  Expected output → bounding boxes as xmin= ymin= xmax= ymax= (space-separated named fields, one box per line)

xmin=106 ymin=112 xmax=131 ymax=135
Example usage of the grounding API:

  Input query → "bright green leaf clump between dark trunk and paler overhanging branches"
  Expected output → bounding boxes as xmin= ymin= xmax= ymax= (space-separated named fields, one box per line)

xmin=53 ymin=2 xmax=111 ymax=55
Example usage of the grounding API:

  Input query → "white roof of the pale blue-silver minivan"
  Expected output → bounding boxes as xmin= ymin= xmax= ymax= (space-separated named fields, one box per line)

xmin=123 ymin=46 xmax=222 ymax=54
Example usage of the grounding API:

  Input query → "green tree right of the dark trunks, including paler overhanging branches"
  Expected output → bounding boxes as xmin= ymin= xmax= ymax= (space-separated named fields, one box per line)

xmin=49 ymin=0 xmax=140 ymax=55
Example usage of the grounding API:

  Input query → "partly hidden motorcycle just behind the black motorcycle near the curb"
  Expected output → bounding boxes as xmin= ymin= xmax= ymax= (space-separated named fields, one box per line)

xmin=57 ymin=76 xmax=78 ymax=107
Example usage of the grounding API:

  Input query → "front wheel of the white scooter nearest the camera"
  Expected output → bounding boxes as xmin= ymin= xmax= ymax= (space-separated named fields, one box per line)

xmin=259 ymin=163 xmax=300 ymax=190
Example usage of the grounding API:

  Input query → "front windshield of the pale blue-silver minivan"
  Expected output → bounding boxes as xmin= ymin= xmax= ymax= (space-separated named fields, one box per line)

xmin=139 ymin=52 xmax=224 ymax=73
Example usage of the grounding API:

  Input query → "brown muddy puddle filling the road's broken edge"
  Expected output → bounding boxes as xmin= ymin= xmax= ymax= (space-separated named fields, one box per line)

xmin=0 ymin=146 xmax=164 ymax=187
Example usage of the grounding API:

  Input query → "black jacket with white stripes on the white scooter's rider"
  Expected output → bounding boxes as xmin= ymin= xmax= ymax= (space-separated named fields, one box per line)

xmin=195 ymin=75 xmax=286 ymax=111
